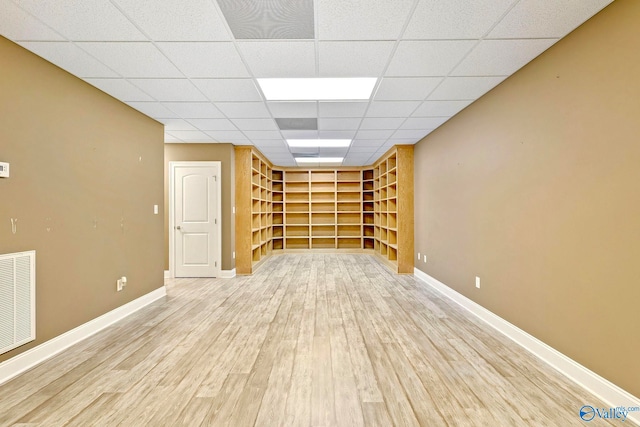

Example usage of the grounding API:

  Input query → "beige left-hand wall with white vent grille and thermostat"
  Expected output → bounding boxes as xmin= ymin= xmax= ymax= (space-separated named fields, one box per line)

xmin=0 ymin=37 xmax=163 ymax=361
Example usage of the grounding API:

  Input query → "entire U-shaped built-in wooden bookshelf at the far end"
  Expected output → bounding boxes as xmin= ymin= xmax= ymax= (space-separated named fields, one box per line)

xmin=235 ymin=146 xmax=413 ymax=274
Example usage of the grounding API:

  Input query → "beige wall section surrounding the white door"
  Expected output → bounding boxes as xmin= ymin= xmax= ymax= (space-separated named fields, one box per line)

xmin=164 ymin=144 xmax=235 ymax=270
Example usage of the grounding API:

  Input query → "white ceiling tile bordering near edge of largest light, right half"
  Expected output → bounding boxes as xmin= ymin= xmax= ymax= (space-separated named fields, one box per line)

xmin=318 ymin=41 xmax=394 ymax=77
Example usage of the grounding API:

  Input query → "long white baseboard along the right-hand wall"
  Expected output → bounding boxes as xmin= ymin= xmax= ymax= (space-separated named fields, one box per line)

xmin=414 ymin=268 xmax=640 ymax=425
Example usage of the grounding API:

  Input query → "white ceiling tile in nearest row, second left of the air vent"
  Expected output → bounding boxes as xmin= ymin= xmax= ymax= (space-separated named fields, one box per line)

xmin=15 ymin=0 xmax=147 ymax=41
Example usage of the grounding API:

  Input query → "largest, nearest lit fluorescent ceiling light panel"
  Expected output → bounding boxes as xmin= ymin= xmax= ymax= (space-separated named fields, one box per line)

xmin=257 ymin=77 xmax=377 ymax=101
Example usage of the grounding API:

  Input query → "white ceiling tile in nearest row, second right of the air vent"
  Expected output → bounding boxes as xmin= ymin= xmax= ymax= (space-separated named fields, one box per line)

xmin=403 ymin=0 xmax=513 ymax=40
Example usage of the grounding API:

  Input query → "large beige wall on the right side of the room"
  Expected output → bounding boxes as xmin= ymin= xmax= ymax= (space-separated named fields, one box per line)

xmin=415 ymin=0 xmax=640 ymax=396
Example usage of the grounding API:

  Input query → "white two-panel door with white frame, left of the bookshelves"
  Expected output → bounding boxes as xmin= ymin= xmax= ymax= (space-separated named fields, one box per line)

xmin=171 ymin=162 xmax=220 ymax=277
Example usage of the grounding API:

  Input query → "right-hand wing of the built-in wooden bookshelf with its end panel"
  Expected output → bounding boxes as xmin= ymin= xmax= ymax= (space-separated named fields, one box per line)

xmin=370 ymin=145 xmax=414 ymax=273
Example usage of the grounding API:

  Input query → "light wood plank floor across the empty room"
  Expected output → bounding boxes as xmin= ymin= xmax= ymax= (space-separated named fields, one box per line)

xmin=0 ymin=254 xmax=629 ymax=427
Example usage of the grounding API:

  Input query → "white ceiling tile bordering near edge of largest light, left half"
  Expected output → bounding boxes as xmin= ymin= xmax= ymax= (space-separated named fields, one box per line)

xmin=237 ymin=41 xmax=316 ymax=78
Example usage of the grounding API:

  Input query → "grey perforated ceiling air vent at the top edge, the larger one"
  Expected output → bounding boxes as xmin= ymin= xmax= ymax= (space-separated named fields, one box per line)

xmin=217 ymin=0 xmax=315 ymax=39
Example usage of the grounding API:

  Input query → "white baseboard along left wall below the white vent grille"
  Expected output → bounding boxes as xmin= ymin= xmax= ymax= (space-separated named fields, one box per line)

xmin=0 ymin=286 xmax=167 ymax=384
